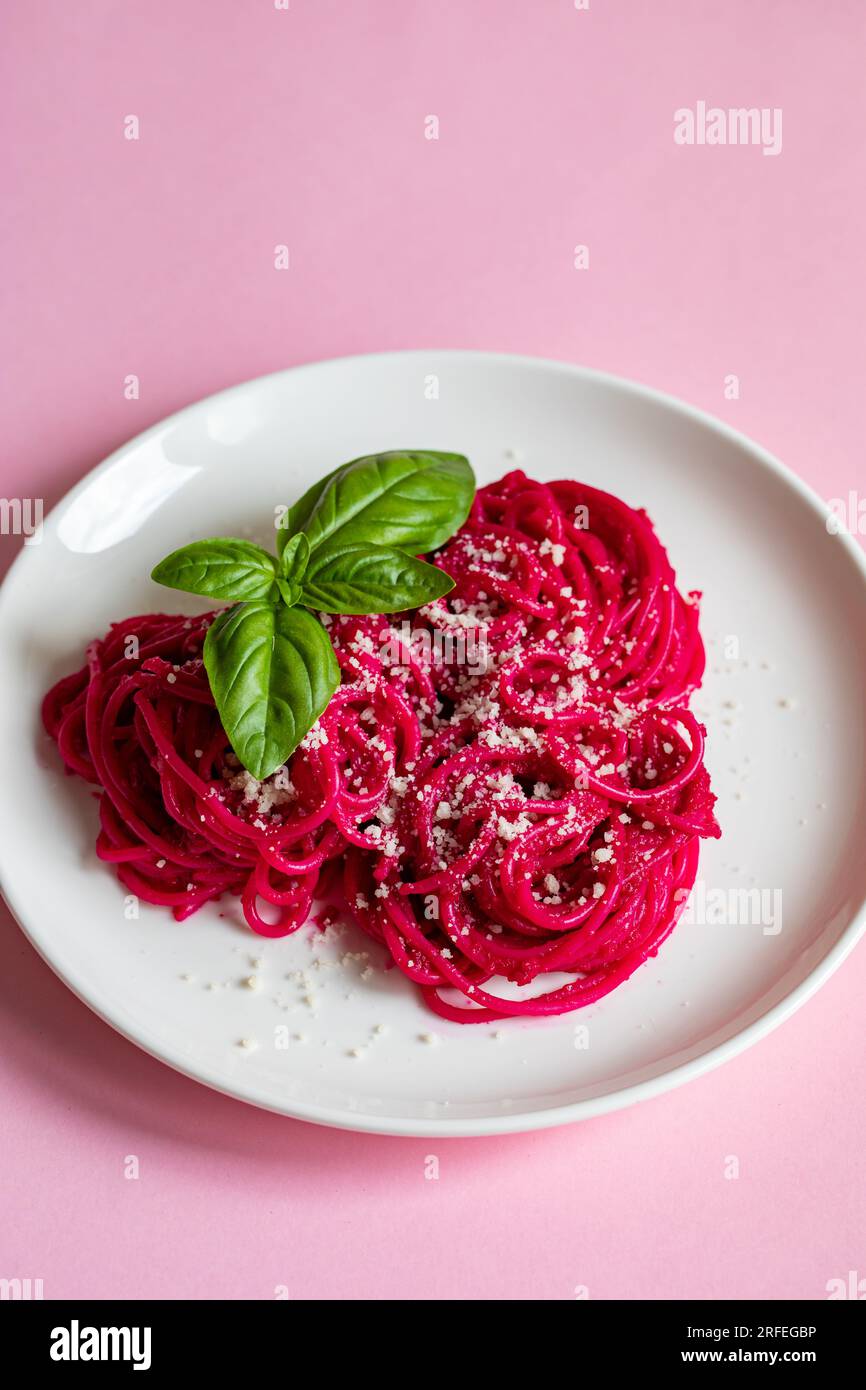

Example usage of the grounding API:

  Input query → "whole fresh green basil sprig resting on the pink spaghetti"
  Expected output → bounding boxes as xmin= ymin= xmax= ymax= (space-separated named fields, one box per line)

xmin=152 ymin=450 xmax=475 ymax=780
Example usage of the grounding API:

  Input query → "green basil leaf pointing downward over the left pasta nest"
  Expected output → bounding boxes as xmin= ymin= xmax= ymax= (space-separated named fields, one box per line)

xmin=204 ymin=602 xmax=339 ymax=781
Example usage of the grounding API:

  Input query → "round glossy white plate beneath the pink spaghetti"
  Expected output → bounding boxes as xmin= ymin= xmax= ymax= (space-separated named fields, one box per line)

xmin=0 ymin=352 xmax=866 ymax=1136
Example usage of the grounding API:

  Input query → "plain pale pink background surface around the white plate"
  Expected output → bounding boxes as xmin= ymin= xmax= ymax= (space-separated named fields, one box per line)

xmin=0 ymin=0 xmax=866 ymax=1298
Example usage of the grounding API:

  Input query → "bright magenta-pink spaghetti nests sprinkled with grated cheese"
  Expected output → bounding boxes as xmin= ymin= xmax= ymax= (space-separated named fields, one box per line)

xmin=43 ymin=473 xmax=719 ymax=1023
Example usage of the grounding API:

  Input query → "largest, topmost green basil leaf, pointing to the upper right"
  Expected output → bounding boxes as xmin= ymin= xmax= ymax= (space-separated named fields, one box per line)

xmin=278 ymin=449 xmax=475 ymax=555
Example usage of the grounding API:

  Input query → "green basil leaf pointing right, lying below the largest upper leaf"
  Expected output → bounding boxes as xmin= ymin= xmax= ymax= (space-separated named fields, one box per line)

xmin=300 ymin=541 xmax=455 ymax=613
